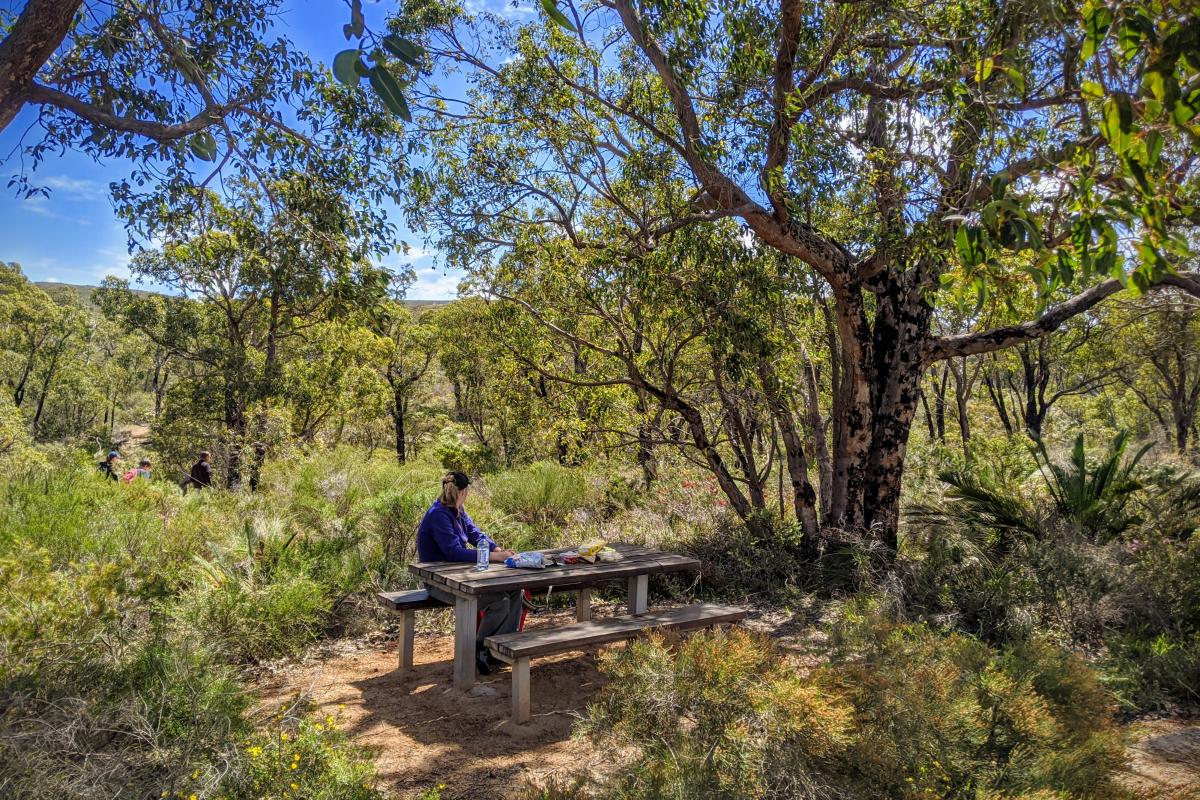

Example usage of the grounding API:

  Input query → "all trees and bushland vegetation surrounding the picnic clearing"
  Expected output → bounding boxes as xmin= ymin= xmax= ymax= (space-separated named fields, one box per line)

xmin=0 ymin=0 xmax=1200 ymax=800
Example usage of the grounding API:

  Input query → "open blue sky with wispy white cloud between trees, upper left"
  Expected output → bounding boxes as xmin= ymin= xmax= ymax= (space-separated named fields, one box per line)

xmin=0 ymin=0 xmax=535 ymax=300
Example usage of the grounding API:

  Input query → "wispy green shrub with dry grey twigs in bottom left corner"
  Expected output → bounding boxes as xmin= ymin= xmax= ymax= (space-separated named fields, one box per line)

xmin=0 ymin=546 xmax=247 ymax=799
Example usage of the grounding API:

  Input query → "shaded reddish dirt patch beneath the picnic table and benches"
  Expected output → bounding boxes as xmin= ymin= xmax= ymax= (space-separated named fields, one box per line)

xmin=257 ymin=612 xmax=609 ymax=800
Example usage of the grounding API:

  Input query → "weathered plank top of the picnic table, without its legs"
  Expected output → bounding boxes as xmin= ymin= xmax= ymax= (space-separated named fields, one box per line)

xmin=408 ymin=542 xmax=700 ymax=595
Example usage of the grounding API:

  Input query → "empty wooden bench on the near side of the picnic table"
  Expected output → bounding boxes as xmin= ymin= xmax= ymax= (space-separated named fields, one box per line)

xmin=484 ymin=603 xmax=746 ymax=724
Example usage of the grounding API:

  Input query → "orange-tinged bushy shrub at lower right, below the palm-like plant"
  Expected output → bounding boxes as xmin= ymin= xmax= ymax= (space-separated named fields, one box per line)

xmin=830 ymin=615 xmax=1124 ymax=798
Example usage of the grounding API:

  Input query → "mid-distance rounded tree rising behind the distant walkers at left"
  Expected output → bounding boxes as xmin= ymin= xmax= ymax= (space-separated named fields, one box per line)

xmin=97 ymin=175 xmax=391 ymax=486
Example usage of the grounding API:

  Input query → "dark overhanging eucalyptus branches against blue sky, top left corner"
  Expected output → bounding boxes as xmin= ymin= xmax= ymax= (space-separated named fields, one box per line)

xmin=0 ymin=0 xmax=398 ymax=225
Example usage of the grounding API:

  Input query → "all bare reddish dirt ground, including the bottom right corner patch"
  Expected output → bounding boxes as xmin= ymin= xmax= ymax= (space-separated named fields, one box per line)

xmin=257 ymin=608 xmax=1200 ymax=800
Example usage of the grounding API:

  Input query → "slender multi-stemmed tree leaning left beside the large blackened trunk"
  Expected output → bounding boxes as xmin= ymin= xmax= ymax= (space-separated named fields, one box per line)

xmin=486 ymin=221 xmax=818 ymax=545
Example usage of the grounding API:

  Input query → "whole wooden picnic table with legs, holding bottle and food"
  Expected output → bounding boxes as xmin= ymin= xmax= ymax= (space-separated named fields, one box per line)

xmin=408 ymin=543 xmax=700 ymax=690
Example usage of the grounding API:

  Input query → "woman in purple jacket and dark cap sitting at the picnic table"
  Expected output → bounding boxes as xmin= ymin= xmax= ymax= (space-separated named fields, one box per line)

xmin=416 ymin=471 xmax=521 ymax=675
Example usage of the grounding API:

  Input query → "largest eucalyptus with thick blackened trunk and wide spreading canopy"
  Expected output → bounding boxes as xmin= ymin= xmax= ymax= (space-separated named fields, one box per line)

xmin=394 ymin=0 xmax=1200 ymax=547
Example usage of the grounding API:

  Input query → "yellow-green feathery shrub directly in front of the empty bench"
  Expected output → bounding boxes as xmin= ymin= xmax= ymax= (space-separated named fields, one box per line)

xmin=582 ymin=628 xmax=852 ymax=799
